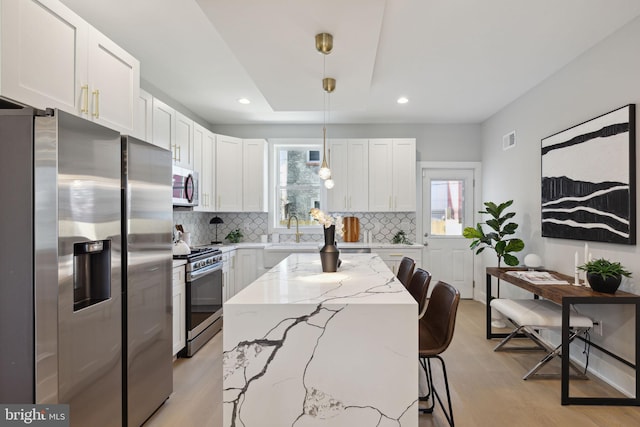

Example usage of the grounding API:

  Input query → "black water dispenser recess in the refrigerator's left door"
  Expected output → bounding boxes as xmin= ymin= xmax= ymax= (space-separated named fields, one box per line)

xmin=73 ymin=240 xmax=111 ymax=311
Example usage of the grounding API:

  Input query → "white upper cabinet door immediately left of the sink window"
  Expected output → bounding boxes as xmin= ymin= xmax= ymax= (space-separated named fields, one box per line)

xmin=242 ymin=139 xmax=267 ymax=212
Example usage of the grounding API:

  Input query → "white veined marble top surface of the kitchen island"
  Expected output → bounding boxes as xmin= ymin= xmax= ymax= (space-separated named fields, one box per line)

xmin=225 ymin=253 xmax=417 ymax=305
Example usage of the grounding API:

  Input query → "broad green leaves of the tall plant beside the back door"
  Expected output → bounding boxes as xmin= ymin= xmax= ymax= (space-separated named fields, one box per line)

xmin=462 ymin=200 xmax=524 ymax=267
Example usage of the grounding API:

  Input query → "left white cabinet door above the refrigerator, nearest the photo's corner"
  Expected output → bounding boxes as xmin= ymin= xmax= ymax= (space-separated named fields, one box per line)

xmin=0 ymin=0 xmax=89 ymax=114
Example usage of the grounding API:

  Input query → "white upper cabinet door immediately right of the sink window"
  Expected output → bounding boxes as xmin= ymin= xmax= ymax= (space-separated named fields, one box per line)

xmin=327 ymin=139 xmax=369 ymax=212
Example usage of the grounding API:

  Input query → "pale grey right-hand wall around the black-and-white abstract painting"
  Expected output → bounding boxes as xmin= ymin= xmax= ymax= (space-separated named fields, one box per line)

xmin=476 ymin=15 xmax=640 ymax=398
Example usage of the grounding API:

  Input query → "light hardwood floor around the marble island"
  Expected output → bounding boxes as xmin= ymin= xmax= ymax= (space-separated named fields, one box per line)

xmin=145 ymin=301 xmax=640 ymax=427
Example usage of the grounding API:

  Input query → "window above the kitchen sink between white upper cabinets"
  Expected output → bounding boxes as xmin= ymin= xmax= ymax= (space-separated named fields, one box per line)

xmin=274 ymin=145 xmax=322 ymax=228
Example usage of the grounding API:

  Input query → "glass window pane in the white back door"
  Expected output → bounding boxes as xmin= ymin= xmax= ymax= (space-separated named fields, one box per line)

xmin=431 ymin=179 xmax=464 ymax=236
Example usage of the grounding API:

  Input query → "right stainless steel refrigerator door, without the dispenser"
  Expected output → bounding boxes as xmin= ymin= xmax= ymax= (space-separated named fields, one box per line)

xmin=122 ymin=136 xmax=173 ymax=426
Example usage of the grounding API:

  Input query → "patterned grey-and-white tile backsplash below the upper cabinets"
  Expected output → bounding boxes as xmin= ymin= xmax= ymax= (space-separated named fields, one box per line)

xmin=173 ymin=210 xmax=416 ymax=246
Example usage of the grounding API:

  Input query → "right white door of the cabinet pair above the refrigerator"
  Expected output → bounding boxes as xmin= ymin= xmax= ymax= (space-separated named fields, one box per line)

xmin=88 ymin=28 xmax=140 ymax=134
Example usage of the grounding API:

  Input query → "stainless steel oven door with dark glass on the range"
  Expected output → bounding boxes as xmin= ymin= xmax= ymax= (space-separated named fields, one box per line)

xmin=186 ymin=263 xmax=222 ymax=341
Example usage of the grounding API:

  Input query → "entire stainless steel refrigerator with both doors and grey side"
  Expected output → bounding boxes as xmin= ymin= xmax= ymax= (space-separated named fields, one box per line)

xmin=0 ymin=108 xmax=172 ymax=426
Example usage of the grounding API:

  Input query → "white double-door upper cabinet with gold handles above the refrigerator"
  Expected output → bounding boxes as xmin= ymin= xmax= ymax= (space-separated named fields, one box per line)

xmin=0 ymin=0 xmax=140 ymax=134
